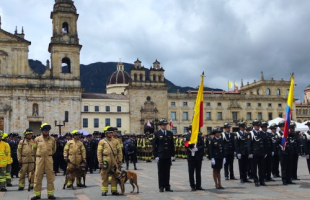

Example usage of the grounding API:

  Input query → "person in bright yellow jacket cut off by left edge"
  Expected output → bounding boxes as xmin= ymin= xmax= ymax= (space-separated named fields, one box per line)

xmin=0 ymin=130 xmax=9 ymax=192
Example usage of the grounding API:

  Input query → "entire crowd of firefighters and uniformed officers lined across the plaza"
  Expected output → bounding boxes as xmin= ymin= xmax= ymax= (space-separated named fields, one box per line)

xmin=0 ymin=119 xmax=310 ymax=200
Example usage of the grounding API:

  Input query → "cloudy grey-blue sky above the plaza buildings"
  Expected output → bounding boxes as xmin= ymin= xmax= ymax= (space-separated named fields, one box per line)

xmin=0 ymin=0 xmax=310 ymax=98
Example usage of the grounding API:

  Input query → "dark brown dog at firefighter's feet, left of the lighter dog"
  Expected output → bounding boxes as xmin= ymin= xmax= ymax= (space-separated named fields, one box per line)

xmin=63 ymin=163 xmax=87 ymax=190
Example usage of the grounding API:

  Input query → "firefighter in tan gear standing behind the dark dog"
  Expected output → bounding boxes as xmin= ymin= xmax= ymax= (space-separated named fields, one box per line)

xmin=64 ymin=130 xmax=86 ymax=188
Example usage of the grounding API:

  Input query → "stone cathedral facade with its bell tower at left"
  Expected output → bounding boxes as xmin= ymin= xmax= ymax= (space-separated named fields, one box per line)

xmin=0 ymin=0 xmax=82 ymax=133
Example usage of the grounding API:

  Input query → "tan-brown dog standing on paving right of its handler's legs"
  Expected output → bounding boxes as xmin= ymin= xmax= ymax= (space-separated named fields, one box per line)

xmin=117 ymin=170 xmax=139 ymax=195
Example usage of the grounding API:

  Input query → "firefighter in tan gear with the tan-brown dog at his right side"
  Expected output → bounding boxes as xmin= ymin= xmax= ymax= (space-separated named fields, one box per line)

xmin=97 ymin=127 xmax=121 ymax=196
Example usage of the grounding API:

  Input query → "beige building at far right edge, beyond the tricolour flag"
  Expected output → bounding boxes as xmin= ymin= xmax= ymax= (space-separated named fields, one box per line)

xmin=296 ymin=85 xmax=310 ymax=122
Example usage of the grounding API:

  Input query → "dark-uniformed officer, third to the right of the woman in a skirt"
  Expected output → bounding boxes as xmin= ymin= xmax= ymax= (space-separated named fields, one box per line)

xmin=248 ymin=120 xmax=267 ymax=187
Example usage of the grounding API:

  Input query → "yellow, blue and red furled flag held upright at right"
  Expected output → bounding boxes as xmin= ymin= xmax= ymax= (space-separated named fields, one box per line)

xmin=282 ymin=74 xmax=294 ymax=150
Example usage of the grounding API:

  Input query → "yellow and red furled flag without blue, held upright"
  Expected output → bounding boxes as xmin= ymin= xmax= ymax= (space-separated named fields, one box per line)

xmin=189 ymin=73 xmax=204 ymax=144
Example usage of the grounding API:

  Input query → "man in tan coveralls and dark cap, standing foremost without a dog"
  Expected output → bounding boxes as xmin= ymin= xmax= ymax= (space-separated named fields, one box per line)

xmin=31 ymin=123 xmax=56 ymax=200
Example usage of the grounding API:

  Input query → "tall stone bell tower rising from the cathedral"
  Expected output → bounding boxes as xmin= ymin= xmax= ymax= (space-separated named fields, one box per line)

xmin=48 ymin=0 xmax=82 ymax=80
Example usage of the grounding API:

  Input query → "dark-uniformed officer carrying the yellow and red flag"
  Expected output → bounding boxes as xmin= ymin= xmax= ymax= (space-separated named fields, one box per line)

xmin=186 ymin=129 xmax=204 ymax=191
